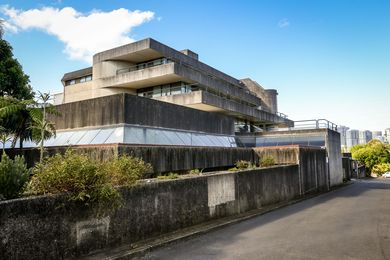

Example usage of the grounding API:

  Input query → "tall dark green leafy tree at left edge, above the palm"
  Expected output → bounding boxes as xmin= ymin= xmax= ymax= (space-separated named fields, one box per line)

xmin=0 ymin=20 xmax=34 ymax=100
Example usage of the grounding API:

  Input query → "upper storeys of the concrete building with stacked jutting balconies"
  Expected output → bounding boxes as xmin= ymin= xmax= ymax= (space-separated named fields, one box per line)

xmin=56 ymin=38 xmax=293 ymax=132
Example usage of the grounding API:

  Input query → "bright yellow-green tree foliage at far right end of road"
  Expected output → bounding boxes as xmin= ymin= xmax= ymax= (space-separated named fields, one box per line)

xmin=351 ymin=140 xmax=390 ymax=172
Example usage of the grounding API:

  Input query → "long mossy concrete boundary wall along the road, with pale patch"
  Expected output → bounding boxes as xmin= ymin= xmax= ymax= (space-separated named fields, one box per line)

xmin=0 ymin=165 xmax=300 ymax=259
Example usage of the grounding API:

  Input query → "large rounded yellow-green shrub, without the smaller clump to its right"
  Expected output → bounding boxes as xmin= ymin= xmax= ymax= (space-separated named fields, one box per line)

xmin=27 ymin=150 xmax=120 ymax=204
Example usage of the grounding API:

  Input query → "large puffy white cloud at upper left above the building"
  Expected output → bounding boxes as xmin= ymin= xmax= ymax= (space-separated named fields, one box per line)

xmin=0 ymin=6 xmax=154 ymax=63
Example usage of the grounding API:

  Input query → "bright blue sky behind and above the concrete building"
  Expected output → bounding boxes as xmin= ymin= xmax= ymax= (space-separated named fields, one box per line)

xmin=0 ymin=0 xmax=390 ymax=130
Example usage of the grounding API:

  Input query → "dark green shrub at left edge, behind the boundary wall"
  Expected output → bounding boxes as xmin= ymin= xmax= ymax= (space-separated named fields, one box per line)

xmin=0 ymin=153 xmax=30 ymax=200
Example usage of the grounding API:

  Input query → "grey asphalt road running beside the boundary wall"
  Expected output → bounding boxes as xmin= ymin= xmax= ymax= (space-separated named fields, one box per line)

xmin=141 ymin=179 xmax=390 ymax=260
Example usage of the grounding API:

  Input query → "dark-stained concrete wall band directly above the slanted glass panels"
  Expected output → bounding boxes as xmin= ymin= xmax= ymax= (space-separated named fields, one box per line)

xmin=52 ymin=94 xmax=234 ymax=135
